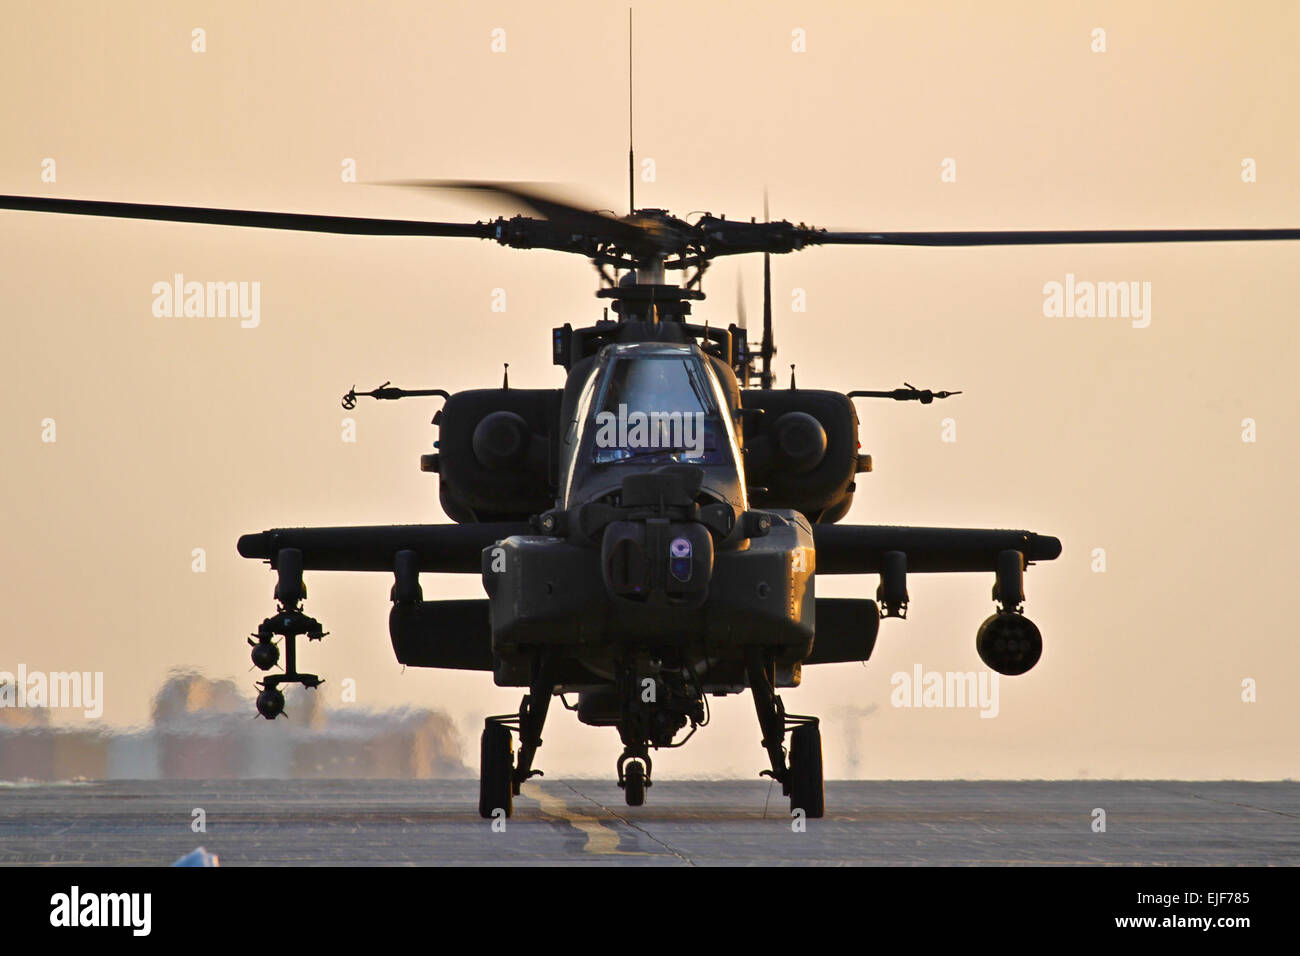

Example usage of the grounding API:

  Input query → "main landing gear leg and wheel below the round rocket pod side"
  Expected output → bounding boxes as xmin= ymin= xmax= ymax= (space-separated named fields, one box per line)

xmin=745 ymin=648 xmax=826 ymax=819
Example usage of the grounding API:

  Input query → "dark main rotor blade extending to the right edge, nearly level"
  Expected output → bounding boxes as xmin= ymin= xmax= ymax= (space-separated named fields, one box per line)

xmin=806 ymin=229 xmax=1300 ymax=246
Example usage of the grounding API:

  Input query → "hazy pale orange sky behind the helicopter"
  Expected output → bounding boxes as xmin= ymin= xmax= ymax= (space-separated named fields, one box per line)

xmin=0 ymin=1 xmax=1300 ymax=778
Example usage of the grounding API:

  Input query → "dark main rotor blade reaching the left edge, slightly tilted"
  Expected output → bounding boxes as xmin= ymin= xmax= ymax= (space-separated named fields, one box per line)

xmin=0 ymin=196 xmax=497 ymax=239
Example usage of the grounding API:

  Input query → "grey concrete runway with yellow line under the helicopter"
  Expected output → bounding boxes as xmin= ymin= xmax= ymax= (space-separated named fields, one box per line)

xmin=0 ymin=779 xmax=1300 ymax=866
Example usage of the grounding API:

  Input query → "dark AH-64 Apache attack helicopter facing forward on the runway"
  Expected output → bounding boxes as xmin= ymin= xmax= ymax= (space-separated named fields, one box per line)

xmin=0 ymin=170 xmax=1300 ymax=817
